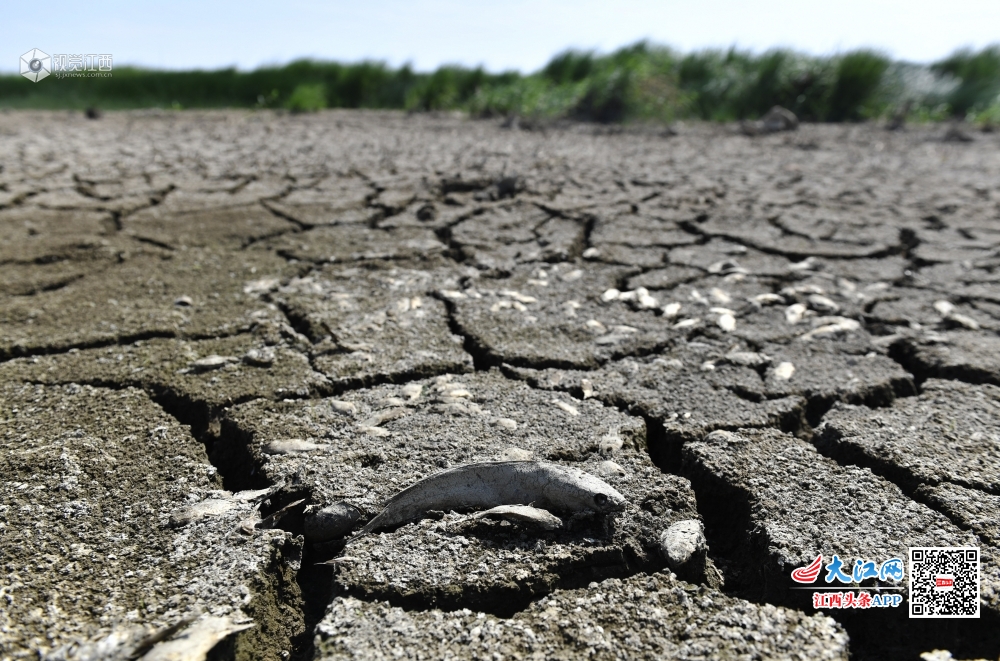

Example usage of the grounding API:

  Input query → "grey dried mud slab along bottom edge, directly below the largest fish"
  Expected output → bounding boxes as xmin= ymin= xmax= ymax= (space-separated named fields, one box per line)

xmin=316 ymin=573 xmax=848 ymax=660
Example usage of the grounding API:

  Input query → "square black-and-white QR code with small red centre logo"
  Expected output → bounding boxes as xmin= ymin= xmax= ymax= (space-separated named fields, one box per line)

xmin=910 ymin=547 xmax=979 ymax=617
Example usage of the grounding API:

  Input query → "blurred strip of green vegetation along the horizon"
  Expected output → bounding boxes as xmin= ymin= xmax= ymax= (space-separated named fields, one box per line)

xmin=0 ymin=42 xmax=1000 ymax=125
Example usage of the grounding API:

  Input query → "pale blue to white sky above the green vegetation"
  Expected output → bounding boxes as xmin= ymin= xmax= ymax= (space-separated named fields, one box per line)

xmin=0 ymin=0 xmax=1000 ymax=72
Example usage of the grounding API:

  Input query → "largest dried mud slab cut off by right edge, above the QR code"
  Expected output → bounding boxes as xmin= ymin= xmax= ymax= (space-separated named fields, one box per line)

xmin=820 ymin=379 xmax=1000 ymax=493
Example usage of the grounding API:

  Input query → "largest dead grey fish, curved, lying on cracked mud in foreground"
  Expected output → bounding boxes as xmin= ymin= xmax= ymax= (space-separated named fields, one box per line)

xmin=355 ymin=461 xmax=625 ymax=539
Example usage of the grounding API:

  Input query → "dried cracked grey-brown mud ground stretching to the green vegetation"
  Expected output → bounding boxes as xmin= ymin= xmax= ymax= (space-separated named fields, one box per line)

xmin=0 ymin=111 xmax=1000 ymax=661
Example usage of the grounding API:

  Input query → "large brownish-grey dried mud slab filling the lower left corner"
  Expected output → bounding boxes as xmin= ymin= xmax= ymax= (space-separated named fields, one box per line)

xmin=0 ymin=382 xmax=303 ymax=658
